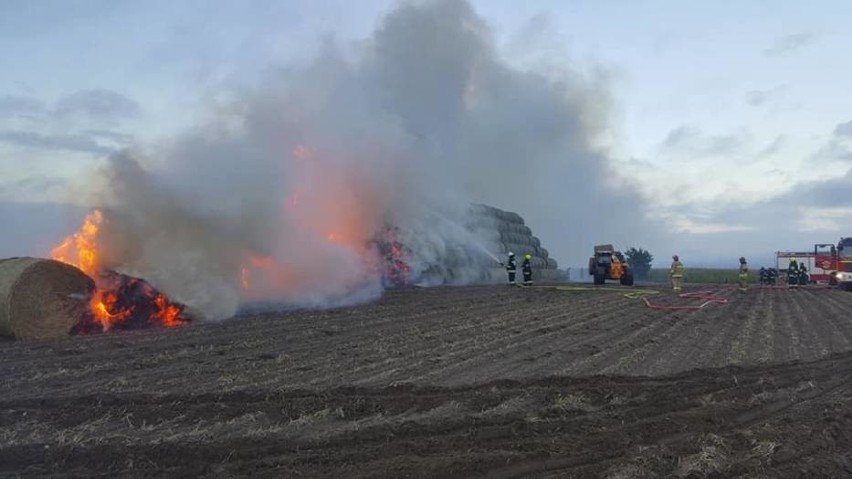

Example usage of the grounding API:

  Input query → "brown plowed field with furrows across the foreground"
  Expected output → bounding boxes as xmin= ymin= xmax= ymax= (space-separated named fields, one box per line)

xmin=0 ymin=285 xmax=852 ymax=477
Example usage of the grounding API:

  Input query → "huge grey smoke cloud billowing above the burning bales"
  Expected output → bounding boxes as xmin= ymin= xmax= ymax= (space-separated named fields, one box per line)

xmin=78 ymin=0 xmax=644 ymax=318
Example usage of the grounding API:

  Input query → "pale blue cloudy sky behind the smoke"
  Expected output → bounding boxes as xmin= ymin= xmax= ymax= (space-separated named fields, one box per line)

xmin=0 ymin=0 xmax=852 ymax=267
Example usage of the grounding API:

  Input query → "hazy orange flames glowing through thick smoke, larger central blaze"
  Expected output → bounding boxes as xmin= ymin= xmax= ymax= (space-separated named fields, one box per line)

xmin=239 ymin=145 xmax=386 ymax=300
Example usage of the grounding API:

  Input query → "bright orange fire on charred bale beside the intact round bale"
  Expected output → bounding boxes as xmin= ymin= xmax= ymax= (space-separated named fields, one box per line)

xmin=50 ymin=210 xmax=185 ymax=333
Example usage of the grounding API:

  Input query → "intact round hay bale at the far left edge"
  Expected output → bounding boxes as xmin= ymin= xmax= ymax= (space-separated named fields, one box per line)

xmin=0 ymin=258 xmax=95 ymax=339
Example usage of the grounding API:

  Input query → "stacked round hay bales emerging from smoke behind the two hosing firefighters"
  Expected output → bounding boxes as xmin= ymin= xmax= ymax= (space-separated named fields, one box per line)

xmin=466 ymin=205 xmax=558 ymax=280
